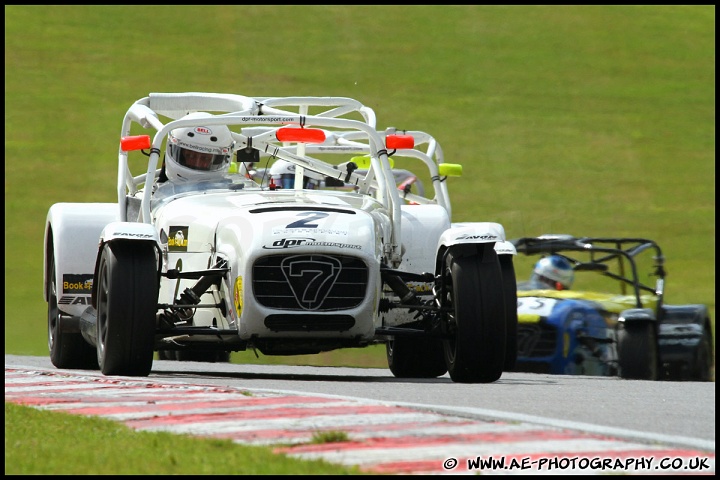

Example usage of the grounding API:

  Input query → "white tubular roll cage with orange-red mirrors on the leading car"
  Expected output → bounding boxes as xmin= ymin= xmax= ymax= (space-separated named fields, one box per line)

xmin=117 ymin=92 xmax=461 ymax=268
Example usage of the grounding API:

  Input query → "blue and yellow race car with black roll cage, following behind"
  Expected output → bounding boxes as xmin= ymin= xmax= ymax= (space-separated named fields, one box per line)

xmin=510 ymin=235 xmax=714 ymax=381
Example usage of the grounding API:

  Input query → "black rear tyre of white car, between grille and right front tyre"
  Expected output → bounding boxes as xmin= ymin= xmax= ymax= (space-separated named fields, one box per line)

xmin=385 ymin=336 xmax=447 ymax=378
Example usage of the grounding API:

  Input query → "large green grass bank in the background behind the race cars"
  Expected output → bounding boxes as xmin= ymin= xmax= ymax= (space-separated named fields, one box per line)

xmin=5 ymin=5 xmax=715 ymax=476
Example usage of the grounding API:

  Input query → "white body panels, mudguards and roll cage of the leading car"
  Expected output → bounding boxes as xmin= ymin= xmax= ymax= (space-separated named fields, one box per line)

xmin=44 ymin=92 xmax=514 ymax=358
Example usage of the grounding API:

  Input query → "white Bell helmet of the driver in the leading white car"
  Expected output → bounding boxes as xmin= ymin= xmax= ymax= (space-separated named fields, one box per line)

xmin=165 ymin=112 xmax=235 ymax=182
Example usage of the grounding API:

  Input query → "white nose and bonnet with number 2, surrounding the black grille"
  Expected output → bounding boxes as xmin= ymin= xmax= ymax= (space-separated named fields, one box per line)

xmin=153 ymin=190 xmax=389 ymax=339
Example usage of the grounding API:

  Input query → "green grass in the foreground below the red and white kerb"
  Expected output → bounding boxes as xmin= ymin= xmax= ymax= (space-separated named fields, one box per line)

xmin=5 ymin=403 xmax=361 ymax=475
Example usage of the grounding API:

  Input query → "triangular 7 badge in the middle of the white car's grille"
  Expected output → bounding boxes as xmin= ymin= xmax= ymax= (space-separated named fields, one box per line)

xmin=280 ymin=255 xmax=342 ymax=310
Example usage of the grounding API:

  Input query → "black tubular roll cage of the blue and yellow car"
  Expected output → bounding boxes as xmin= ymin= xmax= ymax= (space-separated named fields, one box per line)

xmin=509 ymin=235 xmax=666 ymax=312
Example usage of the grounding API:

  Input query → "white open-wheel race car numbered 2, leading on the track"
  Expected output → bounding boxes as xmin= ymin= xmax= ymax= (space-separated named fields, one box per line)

xmin=44 ymin=92 xmax=517 ymax=383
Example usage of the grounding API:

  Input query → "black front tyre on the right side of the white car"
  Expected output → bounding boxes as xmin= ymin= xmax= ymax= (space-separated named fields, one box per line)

xmin=443 ymin=244 xmax=506 ymax=383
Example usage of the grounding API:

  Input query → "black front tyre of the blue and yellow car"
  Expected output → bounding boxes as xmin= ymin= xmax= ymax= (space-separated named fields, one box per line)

xmin=617 ymin=322 xmax=659 ymax=380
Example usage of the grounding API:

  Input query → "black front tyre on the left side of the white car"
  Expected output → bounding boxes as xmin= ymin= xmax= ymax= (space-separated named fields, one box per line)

xmin=97 ymin=242 xmax=159 ymax=376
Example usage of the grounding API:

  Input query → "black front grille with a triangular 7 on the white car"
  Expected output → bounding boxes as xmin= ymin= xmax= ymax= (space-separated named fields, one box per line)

xmin=253 ymin=254 xmax=368 ymax=312
